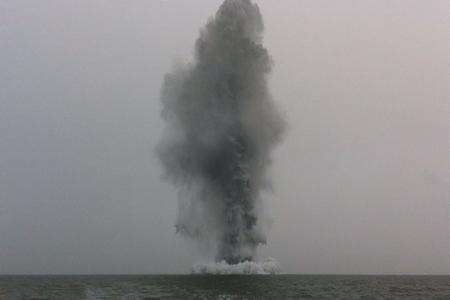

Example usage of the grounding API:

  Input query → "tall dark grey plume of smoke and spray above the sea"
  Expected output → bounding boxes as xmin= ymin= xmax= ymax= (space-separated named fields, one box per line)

xmin=157 ymin=0 xmax=284 ymax=264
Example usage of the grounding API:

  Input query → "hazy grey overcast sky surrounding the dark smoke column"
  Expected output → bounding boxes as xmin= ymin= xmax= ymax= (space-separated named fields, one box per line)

xmin=0 ymin=0 xmax=450 ymax=274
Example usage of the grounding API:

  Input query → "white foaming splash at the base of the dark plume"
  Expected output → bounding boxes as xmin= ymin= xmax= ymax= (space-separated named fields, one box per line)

xmin=191 ymin=258 xmax=281 ymax=275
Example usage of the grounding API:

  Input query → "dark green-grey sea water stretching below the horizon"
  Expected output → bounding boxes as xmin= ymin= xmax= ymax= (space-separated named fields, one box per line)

xmin=0 ymin=275 xmax=450 ymax=299
